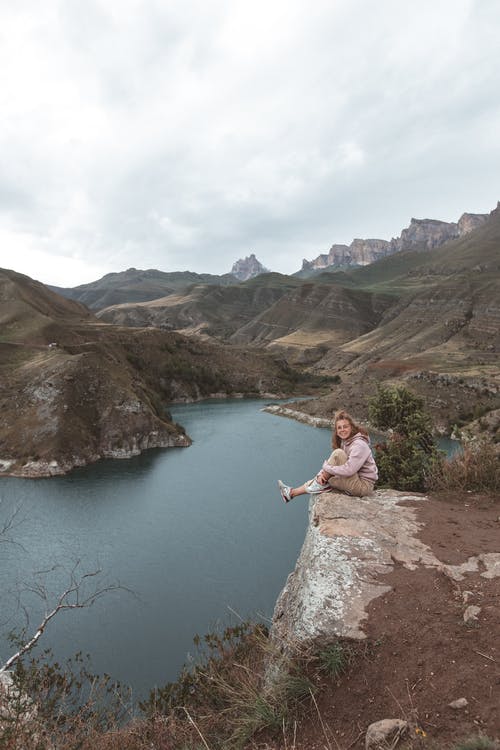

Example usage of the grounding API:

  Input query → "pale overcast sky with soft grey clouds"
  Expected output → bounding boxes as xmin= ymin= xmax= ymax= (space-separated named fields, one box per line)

xmin=0 ymin=0 xmax=500 ymax=286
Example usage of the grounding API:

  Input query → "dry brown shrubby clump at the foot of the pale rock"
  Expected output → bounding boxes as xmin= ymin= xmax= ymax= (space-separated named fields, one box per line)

xmin=140 ymin=622 xmax=314 ymax=750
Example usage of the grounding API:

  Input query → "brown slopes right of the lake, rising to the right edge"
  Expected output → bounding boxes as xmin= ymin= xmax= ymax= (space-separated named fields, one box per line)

xmin=90 ymin=208 xmax=500 ymax=441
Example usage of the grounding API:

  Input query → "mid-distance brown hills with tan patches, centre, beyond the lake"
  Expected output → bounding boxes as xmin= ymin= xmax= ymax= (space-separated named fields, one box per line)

xmin=98 ymin=274 xmax=393 ymax=363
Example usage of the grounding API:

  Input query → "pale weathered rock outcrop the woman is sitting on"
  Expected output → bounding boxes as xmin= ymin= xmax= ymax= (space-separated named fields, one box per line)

xmin=271 ymin=490 xmax=500 ymax=651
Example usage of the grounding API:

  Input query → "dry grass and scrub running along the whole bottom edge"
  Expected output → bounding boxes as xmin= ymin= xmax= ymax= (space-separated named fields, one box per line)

xmin=0 ymin=624 xmax=500 ymax=750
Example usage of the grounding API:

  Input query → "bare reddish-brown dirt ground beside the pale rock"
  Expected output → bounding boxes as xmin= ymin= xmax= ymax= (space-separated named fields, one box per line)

xmin=260 ymin=493 xmax=500 ymax=750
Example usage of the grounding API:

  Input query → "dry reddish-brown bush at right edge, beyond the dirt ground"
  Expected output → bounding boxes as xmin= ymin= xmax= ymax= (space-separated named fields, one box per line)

xmin=427 ymin=440 xmax=500 ymax=492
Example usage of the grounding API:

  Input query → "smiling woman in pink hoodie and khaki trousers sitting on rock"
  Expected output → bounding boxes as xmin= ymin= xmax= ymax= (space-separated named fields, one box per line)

xmin=278 ymin=410 xmax=378 ymax=503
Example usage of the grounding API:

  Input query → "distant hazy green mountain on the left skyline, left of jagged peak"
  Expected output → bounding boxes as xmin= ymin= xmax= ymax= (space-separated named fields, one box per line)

xmin=49 ymin=268 xmax=237 ymax=310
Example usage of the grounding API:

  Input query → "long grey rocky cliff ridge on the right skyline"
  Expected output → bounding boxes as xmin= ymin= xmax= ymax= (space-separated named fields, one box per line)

xmin=302 ymin=213 xmax=488 ymax=272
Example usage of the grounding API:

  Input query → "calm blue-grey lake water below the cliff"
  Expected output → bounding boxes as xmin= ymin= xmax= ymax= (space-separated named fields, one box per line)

xmin=0 ymin=400 xmax=330 ymax=697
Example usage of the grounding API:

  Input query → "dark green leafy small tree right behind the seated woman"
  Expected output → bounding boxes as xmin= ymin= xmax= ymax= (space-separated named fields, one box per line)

xmin=368 ymin=386 xmax=439 ymax=491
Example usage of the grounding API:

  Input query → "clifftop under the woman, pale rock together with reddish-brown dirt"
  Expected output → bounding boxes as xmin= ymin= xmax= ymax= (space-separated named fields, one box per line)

xmin=269 ymin=490 xmax=500 ymax=749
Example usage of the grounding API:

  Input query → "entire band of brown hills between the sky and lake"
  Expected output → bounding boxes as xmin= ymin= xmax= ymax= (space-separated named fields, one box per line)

xmin=0 ymin=207 xmax=500 ymax=476
